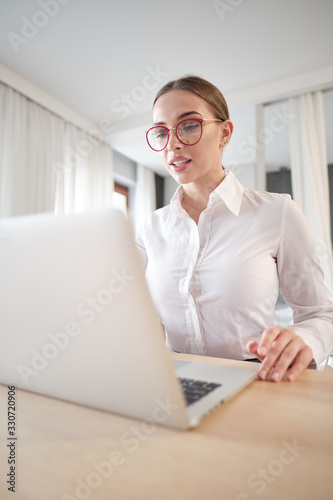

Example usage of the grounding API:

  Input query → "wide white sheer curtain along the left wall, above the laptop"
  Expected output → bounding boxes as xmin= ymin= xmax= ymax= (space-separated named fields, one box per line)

xmin=0 ymin=82 xmax=113 ymax=217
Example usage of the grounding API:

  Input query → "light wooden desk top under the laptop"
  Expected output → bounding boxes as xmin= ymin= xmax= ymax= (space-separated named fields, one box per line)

xmin=0 ymin=355 xmax=333 ymax=500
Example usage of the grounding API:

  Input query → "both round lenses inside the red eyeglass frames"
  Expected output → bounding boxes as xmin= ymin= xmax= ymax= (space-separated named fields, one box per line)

xmin=147 ymin=120 xmax=201 ymax=151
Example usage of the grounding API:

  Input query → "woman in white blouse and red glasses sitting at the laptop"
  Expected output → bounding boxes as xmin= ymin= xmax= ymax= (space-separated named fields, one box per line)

xmin=137 ymin=76 xmax=333 ymax=382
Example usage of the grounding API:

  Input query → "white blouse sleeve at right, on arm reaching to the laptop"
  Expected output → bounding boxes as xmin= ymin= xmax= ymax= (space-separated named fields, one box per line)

xmin=277 ymin=197 xmax=333 ymax=366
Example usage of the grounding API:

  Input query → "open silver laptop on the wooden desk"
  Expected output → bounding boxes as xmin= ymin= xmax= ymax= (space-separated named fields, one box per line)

xmin=0 ymin=209 xmax=257 ymax=429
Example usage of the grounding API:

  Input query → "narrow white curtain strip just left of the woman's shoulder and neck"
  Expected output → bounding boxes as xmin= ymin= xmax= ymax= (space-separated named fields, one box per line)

xmin=135 ymin=165 xmax=156 ymax=229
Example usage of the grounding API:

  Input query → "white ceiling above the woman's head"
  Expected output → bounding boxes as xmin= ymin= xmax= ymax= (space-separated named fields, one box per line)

xmin=0 ymin=0 xmax=333 ymax=173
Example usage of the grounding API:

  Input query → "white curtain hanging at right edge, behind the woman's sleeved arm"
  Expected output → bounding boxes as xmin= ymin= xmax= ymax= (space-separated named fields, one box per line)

xmin=289 ymin=92 xmax=333 ymax=289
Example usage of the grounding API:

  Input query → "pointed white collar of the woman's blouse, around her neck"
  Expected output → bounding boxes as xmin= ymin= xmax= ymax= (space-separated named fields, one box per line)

xmin=170 ymin=170 xmax=244 ymax=217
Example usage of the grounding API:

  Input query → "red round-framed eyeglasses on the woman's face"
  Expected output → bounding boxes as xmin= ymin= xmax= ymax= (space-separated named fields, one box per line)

xmin=146 ymin=118 xmax=224 ymax=151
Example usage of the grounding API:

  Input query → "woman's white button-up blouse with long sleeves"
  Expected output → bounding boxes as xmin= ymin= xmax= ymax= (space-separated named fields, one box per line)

xmin=137 ymin=171 xmax=333 ymax=366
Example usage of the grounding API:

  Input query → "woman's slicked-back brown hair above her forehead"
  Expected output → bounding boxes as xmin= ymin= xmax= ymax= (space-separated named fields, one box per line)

xmin=153 ymin=75 xmax=229 ymax=121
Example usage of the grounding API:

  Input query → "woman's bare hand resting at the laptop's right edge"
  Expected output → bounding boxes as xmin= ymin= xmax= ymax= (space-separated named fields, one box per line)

xmin=247 ymin=326 xmax=313 ymax=382
